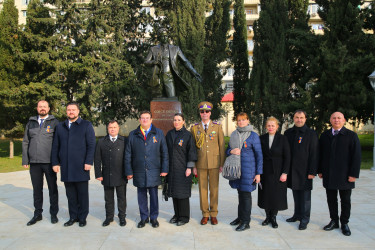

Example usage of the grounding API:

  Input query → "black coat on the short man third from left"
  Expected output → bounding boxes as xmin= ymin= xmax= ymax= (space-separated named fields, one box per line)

xmin=94 ymin=135 xmax=128 ymax=187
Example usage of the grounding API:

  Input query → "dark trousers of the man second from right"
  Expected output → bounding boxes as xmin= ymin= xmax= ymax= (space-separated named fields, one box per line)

xmin=293 ymin=190 xmax=311 ymax=224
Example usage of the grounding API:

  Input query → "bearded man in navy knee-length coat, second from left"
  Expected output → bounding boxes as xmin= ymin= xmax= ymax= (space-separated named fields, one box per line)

xmin=51 ymin=102 xmax=95 ymax=227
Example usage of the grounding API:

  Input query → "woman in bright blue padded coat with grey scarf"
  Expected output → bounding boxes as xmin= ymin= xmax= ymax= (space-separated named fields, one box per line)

xmin=228 ymin=112 xmax=263 ymax=231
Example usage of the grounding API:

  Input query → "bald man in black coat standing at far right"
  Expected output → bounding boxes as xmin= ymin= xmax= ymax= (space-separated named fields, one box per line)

xmin=318 ymin=112 xmax=361 ymax=236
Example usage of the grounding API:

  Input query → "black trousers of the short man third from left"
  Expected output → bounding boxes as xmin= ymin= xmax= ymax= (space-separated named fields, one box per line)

xmin=104 ymin=184 xmax=126 ymax=219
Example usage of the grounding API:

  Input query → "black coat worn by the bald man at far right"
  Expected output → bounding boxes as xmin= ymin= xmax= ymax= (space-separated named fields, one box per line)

xmin=318 ymin=127 xmax=361 ymax=190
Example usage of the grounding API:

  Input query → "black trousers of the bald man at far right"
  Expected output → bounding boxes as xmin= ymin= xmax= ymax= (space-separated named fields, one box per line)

xmin=326 ymin=189 xmax=352 ymax=224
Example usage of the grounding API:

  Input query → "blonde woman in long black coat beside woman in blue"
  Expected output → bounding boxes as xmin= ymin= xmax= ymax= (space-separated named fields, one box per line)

xmin=258 ymin=116 xmax=290 ymax=228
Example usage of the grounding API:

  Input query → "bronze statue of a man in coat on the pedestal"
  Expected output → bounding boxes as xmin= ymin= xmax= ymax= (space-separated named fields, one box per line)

xmin=145 ymin=28 xmax=202 ymax=98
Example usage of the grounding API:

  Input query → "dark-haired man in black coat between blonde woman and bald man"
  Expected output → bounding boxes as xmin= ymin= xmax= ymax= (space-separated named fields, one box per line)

xmin=284 ymin=110 xmax=319 ymax=230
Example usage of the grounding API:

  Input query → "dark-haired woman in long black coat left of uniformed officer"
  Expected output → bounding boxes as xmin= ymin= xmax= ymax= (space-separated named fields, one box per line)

xmin=166 ymin=113 xmax=197 ymax=226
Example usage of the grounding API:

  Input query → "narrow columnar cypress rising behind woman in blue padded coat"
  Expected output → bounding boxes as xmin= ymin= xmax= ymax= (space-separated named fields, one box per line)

xmin=231 ymin=0 xmax=250 ymax=117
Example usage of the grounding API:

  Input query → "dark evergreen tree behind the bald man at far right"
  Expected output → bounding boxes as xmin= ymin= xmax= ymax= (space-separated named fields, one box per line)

xmin=313 ymin=0 xmax=375 ymax=131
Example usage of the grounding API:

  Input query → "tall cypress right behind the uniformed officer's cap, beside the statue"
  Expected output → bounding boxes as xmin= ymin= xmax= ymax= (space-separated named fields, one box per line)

xmin=202 ymin=0 xmax=231 ymax=120
